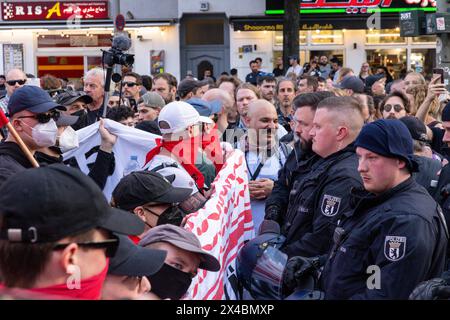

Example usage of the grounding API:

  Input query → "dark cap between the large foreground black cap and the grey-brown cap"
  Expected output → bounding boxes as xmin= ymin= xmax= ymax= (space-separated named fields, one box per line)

xmin=108 ymin=234 xmax=167 ymax=277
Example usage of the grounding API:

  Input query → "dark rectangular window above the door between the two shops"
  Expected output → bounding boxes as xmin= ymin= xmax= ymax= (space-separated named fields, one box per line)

xmin=186 ymin=19 xmax=224 ymax=45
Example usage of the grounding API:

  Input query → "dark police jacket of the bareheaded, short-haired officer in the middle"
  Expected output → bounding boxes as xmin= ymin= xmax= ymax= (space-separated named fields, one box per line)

xmin=281 ymin=145 xmax=362 ymax=257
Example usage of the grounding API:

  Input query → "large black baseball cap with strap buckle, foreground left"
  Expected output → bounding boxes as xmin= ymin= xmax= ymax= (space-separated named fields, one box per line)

xmin=0 ymin=164 xmax=144 ymax=243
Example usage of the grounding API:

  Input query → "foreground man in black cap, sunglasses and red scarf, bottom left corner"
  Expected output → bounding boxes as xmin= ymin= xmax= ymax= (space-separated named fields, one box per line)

xmin=0 ymin=165 xmax=143 ymax=300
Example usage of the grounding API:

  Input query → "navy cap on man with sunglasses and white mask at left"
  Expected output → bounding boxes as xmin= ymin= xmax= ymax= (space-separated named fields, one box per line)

xmin=8 ymin=86 xmax=66 ymax=117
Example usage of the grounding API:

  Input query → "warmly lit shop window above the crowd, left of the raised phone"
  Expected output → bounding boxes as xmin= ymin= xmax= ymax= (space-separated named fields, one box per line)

xmin=366 ymin=48 xmax=406 ymax=79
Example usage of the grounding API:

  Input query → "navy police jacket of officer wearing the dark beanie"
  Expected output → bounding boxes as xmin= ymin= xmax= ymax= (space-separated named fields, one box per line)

xmin=321 ymin=178 xmax=448 ymax=299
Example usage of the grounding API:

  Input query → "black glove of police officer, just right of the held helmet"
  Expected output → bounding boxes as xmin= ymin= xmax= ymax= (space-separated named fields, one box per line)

xmin=283 ymin=257 xmax=322 ymax=292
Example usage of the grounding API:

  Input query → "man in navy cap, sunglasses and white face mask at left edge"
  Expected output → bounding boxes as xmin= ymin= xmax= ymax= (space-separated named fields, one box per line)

xmin=0 ymin=86 xmax=65 ymax=185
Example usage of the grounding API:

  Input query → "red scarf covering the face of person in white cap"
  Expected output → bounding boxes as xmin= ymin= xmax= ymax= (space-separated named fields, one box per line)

xmin=145 ymin=137 xmax=205 ymax=189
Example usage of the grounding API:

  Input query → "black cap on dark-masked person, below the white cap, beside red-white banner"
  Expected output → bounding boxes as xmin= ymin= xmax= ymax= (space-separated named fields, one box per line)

xmin=112 ymin=171 xmax=192 ymax=210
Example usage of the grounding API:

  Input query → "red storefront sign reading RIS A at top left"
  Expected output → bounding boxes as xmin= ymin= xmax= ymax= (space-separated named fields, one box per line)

xmin=2 ymin=1 xmax=108 ymax=21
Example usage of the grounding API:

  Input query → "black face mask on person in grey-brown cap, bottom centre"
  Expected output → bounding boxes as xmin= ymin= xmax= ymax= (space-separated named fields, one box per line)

xmin=147 ymin=263 xmax=192 ymax=300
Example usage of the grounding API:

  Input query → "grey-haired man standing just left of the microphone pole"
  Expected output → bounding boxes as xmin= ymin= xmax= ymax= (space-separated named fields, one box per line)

xmin=84 ymin=68 xmax=106 ymax=126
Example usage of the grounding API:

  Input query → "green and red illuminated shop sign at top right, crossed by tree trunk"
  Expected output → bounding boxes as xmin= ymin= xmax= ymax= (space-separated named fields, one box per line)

xmin=266 ymin=0 xmax=436 ymax=15
